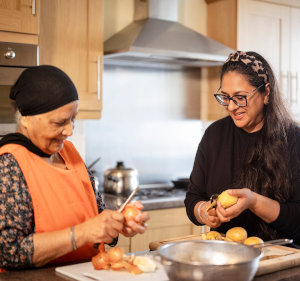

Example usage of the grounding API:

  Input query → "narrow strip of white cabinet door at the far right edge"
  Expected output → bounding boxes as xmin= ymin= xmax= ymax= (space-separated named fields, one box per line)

xmin=288 ymin=8 xmax=300 ymax=121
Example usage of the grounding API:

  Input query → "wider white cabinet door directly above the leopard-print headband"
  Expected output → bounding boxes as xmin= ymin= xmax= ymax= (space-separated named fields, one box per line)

xmin=237 ymin=0 xmax=290 ymax=93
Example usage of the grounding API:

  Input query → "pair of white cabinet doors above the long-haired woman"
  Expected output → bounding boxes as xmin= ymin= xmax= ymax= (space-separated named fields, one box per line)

xmin=237 ymin=0 xmax=300 ymax=121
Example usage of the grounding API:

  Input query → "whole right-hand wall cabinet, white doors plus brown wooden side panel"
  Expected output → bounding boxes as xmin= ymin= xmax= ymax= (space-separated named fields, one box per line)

xmin=204 ymin=0 xmax=300 ymax=120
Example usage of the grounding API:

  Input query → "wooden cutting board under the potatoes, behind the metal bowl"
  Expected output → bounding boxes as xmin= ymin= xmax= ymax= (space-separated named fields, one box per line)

xmin=149 ymin=234 xmax=300 ymax=276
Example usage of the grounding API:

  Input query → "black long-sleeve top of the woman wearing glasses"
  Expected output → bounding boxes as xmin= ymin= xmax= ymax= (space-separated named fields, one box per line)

xmin=184 ymin=116 xmax=300 ymax=246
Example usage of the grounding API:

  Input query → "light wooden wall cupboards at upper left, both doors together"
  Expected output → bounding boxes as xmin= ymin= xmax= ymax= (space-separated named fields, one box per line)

xmin=0 ymin=0 xmax=103 ymax=119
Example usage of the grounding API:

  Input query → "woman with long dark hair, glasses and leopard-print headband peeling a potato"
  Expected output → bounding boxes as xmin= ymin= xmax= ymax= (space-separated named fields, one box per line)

xmin=185 ymin=51 xmax=300 ymax=245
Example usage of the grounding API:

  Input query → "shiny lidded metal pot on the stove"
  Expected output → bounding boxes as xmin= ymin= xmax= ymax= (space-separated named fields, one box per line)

xmin=103 ymin=162 xmax=139 ymax=195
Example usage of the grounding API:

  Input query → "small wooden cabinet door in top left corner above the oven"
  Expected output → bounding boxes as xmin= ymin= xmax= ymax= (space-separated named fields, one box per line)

xmin=0 ymin=0 xmax=40 ymax=34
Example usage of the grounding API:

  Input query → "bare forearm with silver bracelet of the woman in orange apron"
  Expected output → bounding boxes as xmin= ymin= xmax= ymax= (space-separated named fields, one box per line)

xmin=32 ymin=225 xmax=85 ymax=267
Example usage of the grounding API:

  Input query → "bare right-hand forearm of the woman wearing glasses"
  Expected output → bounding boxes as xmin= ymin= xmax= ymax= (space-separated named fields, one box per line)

xmin=249 ymin=192 xmax=280 ymax=223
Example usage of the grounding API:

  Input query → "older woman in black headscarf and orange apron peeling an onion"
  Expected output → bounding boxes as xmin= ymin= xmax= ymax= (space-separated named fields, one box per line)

xmin=0 ymin=66 xmax=149 ymax=270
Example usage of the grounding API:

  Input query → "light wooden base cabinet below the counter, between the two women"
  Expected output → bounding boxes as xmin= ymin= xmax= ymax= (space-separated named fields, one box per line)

xmin=106 ymin=207 xmax=209 ymax=253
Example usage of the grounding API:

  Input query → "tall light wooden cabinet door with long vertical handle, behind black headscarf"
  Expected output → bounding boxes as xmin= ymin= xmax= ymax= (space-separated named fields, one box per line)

xmin=39 ymin=0 xmax=103 ymax=119
